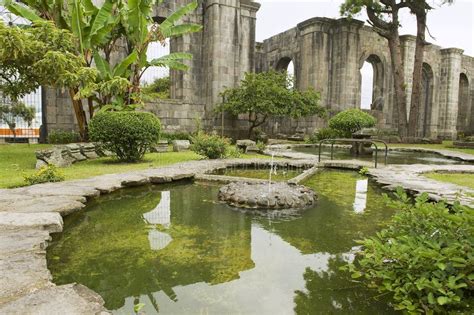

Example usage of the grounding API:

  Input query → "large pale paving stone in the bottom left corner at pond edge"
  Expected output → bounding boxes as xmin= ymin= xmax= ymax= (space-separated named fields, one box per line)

xmin=0 ymin=284 xmax=111 ymax=315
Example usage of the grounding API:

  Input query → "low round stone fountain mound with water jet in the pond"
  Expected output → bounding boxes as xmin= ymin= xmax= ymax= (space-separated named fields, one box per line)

xmin=218 ymin=182 xmax=317 ymax=210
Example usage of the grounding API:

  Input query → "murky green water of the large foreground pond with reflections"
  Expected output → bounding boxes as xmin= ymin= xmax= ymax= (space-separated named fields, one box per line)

xmin=47 ymin=170 xmax=400 ymax=314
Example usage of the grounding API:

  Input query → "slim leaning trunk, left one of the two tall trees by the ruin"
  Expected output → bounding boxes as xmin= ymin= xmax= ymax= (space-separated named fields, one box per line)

xmin=387 ymin=30 xmax=407 ymax=139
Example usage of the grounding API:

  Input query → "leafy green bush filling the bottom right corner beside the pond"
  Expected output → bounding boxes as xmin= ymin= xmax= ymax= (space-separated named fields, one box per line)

xmin=347 ymin=189 xmax=474 ymax=314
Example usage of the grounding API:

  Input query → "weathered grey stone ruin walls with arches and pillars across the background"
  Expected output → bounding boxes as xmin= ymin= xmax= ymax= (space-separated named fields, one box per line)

xmin=45 ymin=0 xmax=474 ymax=139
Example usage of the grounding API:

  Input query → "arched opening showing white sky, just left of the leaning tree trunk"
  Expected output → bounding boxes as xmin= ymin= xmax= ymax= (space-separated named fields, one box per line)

xmin=359 ymin=54 xmax=385 ymax=111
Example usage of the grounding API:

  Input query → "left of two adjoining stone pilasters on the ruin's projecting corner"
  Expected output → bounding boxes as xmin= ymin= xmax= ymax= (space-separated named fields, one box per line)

xmin=298 ymin=18 xmax=332 ymax=107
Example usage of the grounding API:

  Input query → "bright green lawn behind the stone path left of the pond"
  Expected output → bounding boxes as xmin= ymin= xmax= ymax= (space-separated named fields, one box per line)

xmin=0 ymin=144 xmax=268 ymax=188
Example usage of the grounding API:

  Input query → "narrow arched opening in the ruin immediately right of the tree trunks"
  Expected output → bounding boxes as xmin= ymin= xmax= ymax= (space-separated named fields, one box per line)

xmin=418 ymin=63 xmax=434 ymax=137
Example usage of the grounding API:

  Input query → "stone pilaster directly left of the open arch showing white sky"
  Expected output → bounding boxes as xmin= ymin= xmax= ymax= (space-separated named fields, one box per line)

xmin=329 ymin=18 xmax=364 ymax=110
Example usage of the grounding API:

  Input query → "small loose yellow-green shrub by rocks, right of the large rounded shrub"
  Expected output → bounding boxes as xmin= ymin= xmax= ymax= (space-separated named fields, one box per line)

xmin=191 ymin=132 xmax=230 ymax=159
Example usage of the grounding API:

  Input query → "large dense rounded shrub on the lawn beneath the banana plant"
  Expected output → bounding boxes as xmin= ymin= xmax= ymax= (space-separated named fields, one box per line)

xmin=89 ymin=111 xmax=161 ymax=162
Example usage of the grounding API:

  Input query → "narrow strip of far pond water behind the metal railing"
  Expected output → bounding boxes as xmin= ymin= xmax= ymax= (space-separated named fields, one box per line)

xmin=294 ymin=146 xmax=469 ymax=165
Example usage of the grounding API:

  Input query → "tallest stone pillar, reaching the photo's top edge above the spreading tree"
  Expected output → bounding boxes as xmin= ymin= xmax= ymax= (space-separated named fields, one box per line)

xmin=202 ymin=0 xmax=260 ymax=113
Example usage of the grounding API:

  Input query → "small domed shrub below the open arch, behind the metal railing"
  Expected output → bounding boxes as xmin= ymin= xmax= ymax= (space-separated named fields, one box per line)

xmin=329 ymin=108 xmax=376 ymax=138
